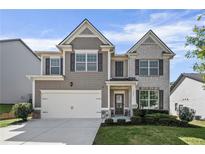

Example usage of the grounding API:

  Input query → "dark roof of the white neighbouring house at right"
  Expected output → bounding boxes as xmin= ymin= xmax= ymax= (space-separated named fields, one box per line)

xmin=170 ymin=73 xmax=205 ymax=94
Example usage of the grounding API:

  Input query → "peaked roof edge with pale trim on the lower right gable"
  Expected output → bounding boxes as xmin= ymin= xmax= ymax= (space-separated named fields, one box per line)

xmin=127 ymin=30 xmax=175 ymax=56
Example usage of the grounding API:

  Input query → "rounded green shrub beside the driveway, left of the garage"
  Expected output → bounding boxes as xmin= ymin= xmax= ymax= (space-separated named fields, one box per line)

xmin=12 ymin=103 xmax=32 ymax=121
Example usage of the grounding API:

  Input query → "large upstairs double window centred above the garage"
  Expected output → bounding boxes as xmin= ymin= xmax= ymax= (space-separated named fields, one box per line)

xmin=75 ymin=53 xmax=97 ymax=72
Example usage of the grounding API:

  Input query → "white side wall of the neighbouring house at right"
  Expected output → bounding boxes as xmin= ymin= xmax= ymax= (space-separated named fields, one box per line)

xmin=170 ymin=77 xmax=205 ymax=119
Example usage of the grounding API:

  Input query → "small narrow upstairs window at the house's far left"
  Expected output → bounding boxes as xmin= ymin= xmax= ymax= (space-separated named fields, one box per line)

xmin=50 ymin=58 xmax=60 ymax=75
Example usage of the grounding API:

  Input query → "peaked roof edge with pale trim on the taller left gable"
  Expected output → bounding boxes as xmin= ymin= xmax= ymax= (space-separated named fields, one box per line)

xmin=58 ymin=19 xmax=114 ymax=47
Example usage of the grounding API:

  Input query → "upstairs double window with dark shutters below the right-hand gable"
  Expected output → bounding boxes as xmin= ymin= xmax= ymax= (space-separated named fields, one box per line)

xmin=139 ymin=60 xmax=159 ymax=76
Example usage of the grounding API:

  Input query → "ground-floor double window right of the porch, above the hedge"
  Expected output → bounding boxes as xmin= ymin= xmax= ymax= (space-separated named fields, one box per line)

xmin=140 ymin=90 xmax=159 ymax=109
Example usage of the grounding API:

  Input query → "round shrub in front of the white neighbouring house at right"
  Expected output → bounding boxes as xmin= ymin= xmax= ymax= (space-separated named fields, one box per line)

xmin=179 ymin=107 xmax=195 ymax=123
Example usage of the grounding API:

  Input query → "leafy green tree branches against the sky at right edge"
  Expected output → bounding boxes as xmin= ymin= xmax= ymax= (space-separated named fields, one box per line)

xmin=185 ymin=14 xmax=205 ymax=76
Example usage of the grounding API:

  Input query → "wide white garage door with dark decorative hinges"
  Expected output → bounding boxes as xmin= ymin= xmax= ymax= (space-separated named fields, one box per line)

xmin=41 ymin=90 xmax=101 ymax=118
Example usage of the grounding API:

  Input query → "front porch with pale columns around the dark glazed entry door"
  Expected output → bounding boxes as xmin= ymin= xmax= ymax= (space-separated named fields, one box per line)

xmin=106 ymin=79 xmax=138 ymax=117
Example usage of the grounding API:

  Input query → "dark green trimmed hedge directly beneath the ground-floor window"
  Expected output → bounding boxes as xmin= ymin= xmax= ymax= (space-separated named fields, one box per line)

xmin=133 ymin=109 xmax=169 ymax=117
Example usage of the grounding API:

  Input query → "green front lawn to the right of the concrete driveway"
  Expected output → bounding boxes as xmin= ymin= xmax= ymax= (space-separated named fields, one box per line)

xmin=94 ymin=121 xmax=205 ymax=145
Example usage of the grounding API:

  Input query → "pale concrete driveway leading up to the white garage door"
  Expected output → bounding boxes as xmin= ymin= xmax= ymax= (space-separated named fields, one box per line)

xmin=0 ymin=119 xmax=101 ymax=145
